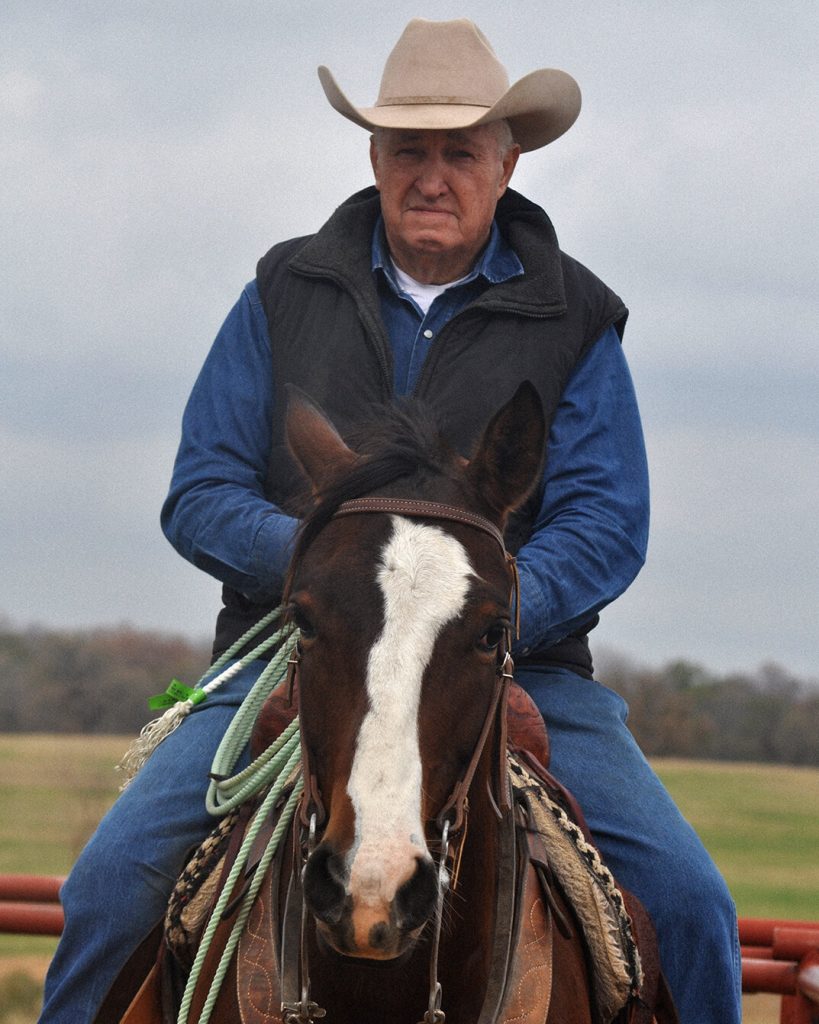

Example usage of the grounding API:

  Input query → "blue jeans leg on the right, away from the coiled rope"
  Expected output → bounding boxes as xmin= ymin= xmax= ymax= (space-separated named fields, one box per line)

xmin=515 ymin=669 xmax=742 ymax=1024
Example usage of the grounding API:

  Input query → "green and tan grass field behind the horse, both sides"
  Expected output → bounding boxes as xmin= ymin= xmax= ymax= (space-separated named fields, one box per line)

xmin=0 ymin=734 xmax=819 ymax=1024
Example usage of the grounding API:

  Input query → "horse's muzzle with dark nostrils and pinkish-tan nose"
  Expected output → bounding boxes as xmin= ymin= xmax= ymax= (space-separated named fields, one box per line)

xmin=304 ymin=842 xmax=437 ymax=961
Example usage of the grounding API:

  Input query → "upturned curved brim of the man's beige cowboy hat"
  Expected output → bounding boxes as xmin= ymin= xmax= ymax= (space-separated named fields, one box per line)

xmin=318 ymin=66 xmax=580 ymax=153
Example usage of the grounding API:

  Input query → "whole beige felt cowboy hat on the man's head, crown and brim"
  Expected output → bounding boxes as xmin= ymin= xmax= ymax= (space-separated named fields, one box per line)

xmin=318 ymin=18 xmax=580 ymax=153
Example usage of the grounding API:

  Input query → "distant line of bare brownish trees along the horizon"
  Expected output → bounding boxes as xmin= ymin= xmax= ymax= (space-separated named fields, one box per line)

xmin=0 ymin=621 xmax=819 ymax=766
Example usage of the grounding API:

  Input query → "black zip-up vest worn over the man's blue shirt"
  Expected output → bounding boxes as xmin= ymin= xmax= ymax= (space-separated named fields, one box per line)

xmin=214 ymin=187 xmax=628 ymax=674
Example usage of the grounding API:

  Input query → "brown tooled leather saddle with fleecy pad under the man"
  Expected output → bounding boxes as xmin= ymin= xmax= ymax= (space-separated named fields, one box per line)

xmin=115 ymin=684 xmax=677 ymax=1024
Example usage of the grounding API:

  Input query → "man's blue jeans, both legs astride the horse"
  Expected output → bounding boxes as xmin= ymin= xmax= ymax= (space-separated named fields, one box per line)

xmin=40 ymin=663 xmax=741 ymax=1024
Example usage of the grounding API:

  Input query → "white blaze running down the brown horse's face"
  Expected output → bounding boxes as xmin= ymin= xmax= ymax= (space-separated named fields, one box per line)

xmin=348 ymin=516 xmax=473 ymax=907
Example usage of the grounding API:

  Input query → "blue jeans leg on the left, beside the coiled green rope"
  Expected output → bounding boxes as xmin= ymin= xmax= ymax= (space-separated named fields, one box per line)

xmin=40 ymin=662 xmax=265 ymax=1024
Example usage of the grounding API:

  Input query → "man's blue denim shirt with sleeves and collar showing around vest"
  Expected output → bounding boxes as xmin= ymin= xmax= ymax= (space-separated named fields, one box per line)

xmin=162 ymin=232 xmax=648 ymax=653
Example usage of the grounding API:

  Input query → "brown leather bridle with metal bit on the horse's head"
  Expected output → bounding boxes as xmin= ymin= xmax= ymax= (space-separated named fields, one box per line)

xmin=282 ymin=498 xmax=520 ymax=1024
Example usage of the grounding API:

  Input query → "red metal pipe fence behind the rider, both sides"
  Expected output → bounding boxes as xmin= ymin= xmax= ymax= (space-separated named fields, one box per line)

xmin=0 ymin=874 xmax=819 ymax=1024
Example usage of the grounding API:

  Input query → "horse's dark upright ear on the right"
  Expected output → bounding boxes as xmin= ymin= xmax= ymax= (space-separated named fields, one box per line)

xmin=467 ymin=381 xmax=546 ymax=521
